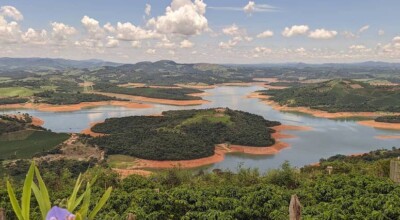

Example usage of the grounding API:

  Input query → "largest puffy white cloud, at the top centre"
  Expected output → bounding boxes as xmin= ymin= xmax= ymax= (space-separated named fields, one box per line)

xmin=148 ymin=0 xmax=209 ymax=35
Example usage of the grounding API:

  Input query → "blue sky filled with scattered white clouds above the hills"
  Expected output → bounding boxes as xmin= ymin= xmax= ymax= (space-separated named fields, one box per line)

xmin=0 ymin=0 xmax=400 ymax=64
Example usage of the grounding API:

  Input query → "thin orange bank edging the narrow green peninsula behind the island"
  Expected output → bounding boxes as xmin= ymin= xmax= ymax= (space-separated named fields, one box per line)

xmin=94 ymin=92 xmax=209 ymax=106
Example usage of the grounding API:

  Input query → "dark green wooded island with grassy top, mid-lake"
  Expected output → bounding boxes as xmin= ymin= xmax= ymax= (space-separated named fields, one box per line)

xmin=90 ymin=109 xmax=280 ymax=160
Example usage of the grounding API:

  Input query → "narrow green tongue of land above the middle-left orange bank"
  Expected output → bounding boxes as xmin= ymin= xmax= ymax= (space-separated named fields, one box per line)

xmin=94 ymin=83 xmax=202 ymax=100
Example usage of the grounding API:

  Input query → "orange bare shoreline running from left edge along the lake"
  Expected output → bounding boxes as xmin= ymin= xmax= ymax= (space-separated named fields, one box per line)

xmin=0 ymin=101 xmax=153 ymax=112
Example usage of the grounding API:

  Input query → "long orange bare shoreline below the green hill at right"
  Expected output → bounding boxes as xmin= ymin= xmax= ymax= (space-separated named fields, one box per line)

xmin=247 ymin=92 xmax=396 ymax=119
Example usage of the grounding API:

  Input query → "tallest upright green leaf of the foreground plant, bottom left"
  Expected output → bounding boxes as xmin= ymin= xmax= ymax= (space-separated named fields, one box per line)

xmin=21 ymin=161 xmax=35 ymax=220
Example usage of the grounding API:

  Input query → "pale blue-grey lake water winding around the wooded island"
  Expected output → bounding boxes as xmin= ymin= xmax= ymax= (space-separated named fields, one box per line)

xmin=0 ymin=86 xmax=400 ymax=172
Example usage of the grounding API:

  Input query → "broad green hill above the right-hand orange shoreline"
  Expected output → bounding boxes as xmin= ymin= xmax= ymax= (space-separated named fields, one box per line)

xmin=262 ymin=79 xmax=400 ymax=112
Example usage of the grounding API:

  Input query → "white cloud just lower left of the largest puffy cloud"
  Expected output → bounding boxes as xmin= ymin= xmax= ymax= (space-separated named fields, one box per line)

xmin=116 ymin=22 xmax=159 ymax=41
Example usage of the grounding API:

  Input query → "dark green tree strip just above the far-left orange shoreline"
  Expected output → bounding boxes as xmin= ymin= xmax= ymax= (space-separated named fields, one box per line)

xmin=35 ymin=91 xmax=122 ymax=105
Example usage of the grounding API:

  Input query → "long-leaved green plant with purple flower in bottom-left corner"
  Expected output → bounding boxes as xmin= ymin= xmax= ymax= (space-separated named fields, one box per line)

xmin=7 ymin=162 xmax=112 ymax=220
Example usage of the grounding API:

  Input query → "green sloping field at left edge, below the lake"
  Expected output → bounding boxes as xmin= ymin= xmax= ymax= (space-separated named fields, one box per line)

xmin=0 ymin=130 xmax=69 ymax=159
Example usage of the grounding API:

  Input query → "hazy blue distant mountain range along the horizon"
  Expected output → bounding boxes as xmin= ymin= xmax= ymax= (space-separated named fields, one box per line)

xmin=0 ymin=57 xmax=400 ymax=71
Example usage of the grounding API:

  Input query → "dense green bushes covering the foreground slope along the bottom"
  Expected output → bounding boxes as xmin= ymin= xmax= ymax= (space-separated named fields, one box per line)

xmin=0 ymin=148 xmax=400 ymax=220
